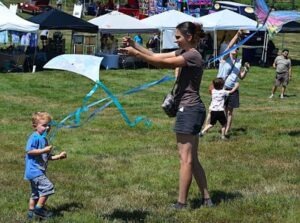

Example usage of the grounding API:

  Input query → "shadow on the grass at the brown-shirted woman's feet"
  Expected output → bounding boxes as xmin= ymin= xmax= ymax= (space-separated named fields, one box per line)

xmin=191 ymin=190 xmax=243 ymax=209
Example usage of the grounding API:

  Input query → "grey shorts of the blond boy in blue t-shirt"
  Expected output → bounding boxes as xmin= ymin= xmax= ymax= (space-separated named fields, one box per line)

xmin=30 ymin=175 xmax=54 ymax=200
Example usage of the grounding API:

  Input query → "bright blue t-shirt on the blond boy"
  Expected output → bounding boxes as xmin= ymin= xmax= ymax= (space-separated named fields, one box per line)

xmin=24 ymin=132 xmax=49 ymax=180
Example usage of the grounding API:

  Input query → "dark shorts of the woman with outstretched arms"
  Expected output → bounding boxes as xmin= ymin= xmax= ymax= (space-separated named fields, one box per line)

xmin=174 ymin=103 xmax=206 ymax=135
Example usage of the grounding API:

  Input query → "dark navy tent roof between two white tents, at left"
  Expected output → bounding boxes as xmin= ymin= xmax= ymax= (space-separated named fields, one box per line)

xmin=28 ymin=9 xmax=98 ymax=33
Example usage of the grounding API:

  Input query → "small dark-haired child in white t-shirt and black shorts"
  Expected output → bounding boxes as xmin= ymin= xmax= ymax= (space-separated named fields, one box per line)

xmin=199 ymin=78 xmax=239 ymax=139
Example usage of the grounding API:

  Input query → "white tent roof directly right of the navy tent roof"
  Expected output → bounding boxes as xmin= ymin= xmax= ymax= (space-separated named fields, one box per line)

xmin=89 ymin=11 xmax=157 ymax=33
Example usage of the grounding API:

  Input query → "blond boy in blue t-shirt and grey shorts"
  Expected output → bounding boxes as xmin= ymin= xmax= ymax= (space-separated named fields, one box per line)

xmin=24 ymin=112 xmax=67 ymax=219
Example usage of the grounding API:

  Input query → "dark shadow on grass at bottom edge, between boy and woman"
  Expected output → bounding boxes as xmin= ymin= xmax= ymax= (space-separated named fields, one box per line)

xmin=104 ymin=209 xmax=149 ymax=222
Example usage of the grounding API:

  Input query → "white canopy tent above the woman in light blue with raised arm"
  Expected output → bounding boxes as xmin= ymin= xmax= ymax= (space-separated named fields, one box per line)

xmin=196 ymin=9 xmax=267 ymax=63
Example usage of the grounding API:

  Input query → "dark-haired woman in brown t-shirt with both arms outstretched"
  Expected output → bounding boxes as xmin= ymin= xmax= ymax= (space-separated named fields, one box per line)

xmin=120 ymin=22 xmax=212 ymax=209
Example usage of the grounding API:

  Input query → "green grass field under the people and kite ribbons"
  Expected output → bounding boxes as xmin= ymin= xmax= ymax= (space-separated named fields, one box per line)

xmin=0 ymin=61 xmax=300 ymax=222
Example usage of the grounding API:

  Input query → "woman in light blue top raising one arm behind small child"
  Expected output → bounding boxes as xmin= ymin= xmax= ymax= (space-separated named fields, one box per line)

xmin=217 ymin=30 xmax=250 ymax=136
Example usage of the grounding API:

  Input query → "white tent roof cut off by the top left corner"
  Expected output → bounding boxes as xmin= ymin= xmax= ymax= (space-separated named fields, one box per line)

xmin=0 ymin=2 xmax=39 ymax=33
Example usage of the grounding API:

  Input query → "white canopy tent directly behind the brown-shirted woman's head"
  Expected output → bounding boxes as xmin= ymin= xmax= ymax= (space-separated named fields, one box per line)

xmin=142 ymin=10 xmax=196 ymax=49
